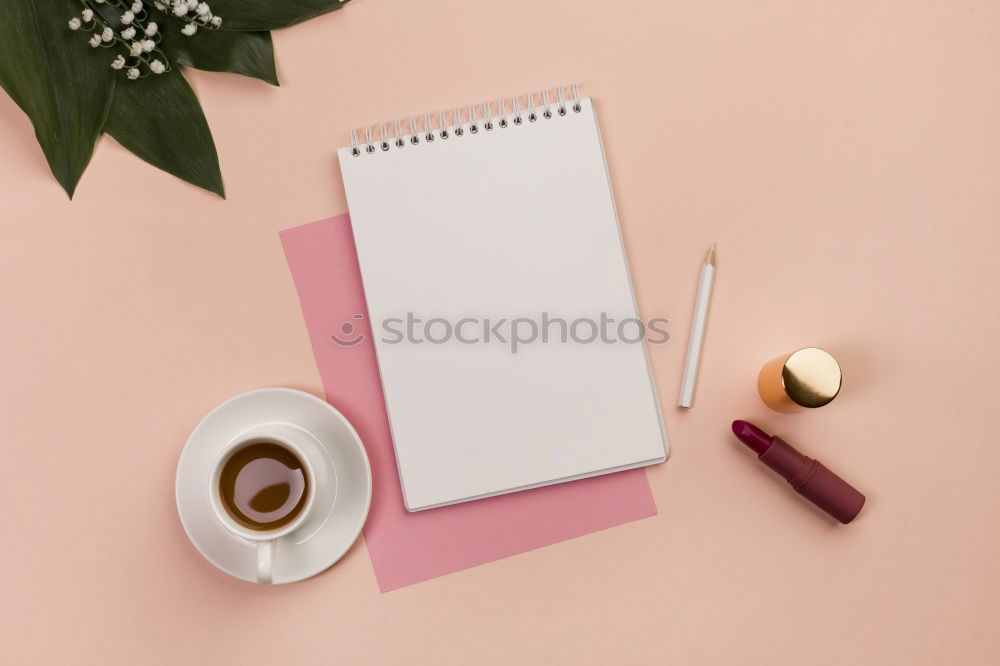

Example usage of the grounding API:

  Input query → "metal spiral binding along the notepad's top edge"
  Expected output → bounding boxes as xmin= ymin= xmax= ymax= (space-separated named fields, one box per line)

xmin=351 ymin=83 xmax=583 ymax=157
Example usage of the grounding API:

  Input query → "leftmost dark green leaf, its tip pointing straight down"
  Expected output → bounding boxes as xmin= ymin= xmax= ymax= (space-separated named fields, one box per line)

xmin=0 ymin=0 xmax=115 ymax=198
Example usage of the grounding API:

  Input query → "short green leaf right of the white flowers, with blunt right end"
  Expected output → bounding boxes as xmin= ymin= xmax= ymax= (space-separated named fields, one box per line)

xmin=156 ymin=12 xmax=278 ymax=86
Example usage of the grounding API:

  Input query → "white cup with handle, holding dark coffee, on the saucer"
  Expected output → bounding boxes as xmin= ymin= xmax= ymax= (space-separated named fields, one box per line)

xmin=209 ymin=423 xmax=336 ymax=584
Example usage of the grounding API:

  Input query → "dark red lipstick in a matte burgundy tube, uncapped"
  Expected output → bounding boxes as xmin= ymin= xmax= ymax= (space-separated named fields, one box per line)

xmin=733 ymin=421 xmax=865 ymax=525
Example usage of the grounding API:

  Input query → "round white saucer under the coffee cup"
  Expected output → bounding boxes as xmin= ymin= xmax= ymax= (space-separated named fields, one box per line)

xmin=176 ymin=388 xmax=372 ymax=583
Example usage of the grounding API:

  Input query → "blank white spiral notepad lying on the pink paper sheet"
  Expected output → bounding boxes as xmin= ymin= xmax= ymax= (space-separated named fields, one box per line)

xmin=333 ymin=86 xmax=668 ymax=511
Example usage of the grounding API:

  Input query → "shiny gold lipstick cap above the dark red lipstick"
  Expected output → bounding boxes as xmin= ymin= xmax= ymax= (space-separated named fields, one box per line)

xmin=757 ymin=347 xmax=842 ymax=412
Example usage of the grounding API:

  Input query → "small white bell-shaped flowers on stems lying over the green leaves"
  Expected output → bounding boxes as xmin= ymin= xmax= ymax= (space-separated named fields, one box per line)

xmin=68 ymin=0 xmax=222 ymax=81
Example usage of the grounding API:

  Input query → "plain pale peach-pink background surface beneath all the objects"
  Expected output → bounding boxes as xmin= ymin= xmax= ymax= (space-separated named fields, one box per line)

xmin=0 ymin=0 xmax=1000 ymax=665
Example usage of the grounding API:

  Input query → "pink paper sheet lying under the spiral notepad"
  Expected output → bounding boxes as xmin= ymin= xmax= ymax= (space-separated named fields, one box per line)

xmin=281 ymin=213 xmax=656 ymax=592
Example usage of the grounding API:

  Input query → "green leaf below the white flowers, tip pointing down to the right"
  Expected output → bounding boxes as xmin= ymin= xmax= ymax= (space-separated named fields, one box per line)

xmin=104 ymin=69 xmax=226 ymax=198
